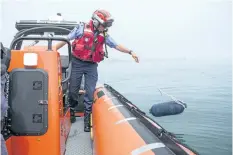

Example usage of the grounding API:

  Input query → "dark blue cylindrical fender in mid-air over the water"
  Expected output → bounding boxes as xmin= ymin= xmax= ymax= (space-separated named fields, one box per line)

xmin=150 ymin=101 xmax=187 ymax=117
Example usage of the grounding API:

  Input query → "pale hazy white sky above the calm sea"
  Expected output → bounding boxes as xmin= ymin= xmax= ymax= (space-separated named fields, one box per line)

xmin=0 ymin=0 xmax=232 ymax=58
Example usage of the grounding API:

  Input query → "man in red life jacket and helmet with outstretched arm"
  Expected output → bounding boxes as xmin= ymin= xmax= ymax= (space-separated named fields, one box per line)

xmin=56 ymin=10 xmax=139 ymax=132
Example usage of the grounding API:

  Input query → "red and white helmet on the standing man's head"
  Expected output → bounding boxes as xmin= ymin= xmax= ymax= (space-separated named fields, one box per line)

xmin=92 ymin=10 xmax=114 ymax=28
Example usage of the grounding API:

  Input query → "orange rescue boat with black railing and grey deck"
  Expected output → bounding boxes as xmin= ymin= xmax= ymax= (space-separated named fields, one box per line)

xmin=2 ymin=21 xmax=198 ymax=155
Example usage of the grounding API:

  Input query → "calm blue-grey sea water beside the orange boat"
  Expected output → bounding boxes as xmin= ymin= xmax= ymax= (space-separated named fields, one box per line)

xmin=99 ymin=59 xmax=232 ymax=155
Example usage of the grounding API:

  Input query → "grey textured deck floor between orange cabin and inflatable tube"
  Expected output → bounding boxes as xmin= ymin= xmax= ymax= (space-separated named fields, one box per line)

xmin=65 ymin=117 xmax=94 ymax=155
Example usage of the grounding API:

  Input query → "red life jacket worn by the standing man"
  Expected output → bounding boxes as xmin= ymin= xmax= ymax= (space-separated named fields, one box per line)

xmin=72 ymin=21 xmax=105 ymax=63
